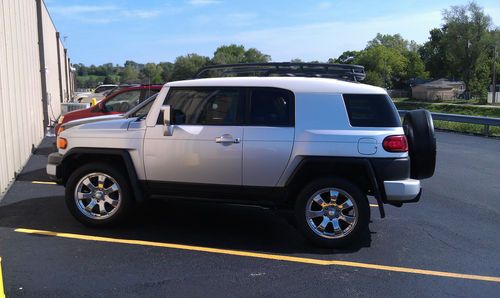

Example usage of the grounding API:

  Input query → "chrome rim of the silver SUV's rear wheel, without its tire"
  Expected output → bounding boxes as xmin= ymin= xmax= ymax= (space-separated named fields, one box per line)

xmin=305 ymin=188 xmax=358 ymax=239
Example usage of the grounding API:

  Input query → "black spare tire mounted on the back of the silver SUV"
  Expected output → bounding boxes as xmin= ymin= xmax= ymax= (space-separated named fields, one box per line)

xmin=403 ymin=109 xmax=436 ymax=179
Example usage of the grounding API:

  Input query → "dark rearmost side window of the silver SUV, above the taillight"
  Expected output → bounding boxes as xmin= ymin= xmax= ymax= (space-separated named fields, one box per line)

xmin=343 ymin=94 xmax=401 ymax=127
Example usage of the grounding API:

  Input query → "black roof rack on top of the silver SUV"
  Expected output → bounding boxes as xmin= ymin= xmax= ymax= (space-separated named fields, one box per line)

xmin=194 ymin=62 xmax=366 ymax=82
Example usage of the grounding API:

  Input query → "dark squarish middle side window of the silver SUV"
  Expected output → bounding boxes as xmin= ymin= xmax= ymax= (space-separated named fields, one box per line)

xmin=249 ymin=88 xmax=294 ymax=126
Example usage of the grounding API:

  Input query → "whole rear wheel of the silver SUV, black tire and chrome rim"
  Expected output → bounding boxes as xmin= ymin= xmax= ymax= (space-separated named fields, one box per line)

xmin=295 ymin=178 xmax=370 ymax=248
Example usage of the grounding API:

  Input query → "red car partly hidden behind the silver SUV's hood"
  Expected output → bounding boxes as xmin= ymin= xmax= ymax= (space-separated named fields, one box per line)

xmin=55 ymin=85 xmax=163 ymax=135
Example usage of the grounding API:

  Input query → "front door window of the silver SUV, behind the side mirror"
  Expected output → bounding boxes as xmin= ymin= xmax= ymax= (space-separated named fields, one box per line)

xmin=164 ymin=88 xmax=242 ymax=125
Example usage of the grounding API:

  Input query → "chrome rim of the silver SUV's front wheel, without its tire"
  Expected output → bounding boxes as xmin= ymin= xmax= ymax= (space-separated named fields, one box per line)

xmin=74 ymin=173 xmax=121 ymax=220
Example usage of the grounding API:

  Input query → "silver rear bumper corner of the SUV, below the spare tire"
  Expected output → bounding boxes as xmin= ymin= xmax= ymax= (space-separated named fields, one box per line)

xmin=384 ymin=179 xmax=422 ymax=203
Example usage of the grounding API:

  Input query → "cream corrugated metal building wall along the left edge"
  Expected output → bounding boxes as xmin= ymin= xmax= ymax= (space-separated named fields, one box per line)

xmin=0 ymin=0 xmax=71 ymax=196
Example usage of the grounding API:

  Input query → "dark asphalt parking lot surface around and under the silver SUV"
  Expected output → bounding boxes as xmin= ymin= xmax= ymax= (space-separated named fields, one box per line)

xmin=0 ymin=132 xmax=500 ymax=297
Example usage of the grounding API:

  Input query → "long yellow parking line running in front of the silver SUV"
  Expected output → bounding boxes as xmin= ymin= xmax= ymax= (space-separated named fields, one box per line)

xmin=15 ymin=228 xmax=500 ymax=282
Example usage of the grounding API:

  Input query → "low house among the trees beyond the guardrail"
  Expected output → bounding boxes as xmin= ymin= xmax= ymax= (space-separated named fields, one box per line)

xmin=411 ymin=79 xmax=465 ymax=100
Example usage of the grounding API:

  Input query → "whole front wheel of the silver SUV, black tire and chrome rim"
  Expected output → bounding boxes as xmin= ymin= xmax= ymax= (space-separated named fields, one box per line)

xmin=65 ymin=163 xmax=133 ymax=226
